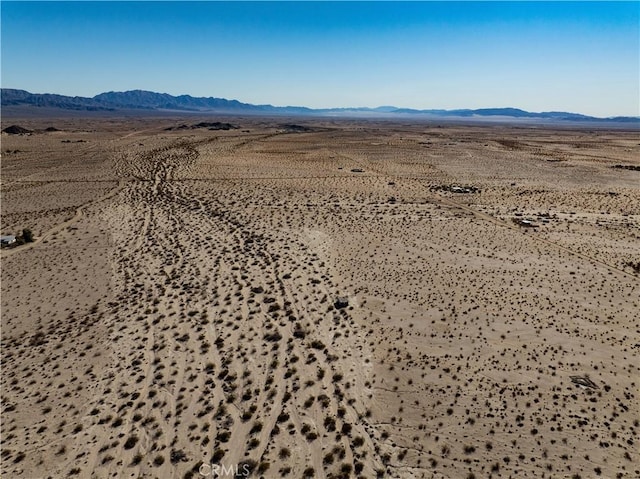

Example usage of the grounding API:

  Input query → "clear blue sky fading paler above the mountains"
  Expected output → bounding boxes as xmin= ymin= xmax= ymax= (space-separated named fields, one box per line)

xmin=1 ymin=1 xmax=640 ymax=116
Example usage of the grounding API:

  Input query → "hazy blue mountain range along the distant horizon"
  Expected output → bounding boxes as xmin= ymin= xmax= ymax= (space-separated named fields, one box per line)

xmin=0 ymin=88 xmax=640 ymax=123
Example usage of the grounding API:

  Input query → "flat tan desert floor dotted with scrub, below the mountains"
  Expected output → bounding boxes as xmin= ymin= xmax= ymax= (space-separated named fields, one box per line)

xmin=1 ymin=118 xmax=640 ymax=479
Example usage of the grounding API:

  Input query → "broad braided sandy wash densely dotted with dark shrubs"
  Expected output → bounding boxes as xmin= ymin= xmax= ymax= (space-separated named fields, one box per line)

xmin=66 ymin=137 xmax=382 ymax=477
